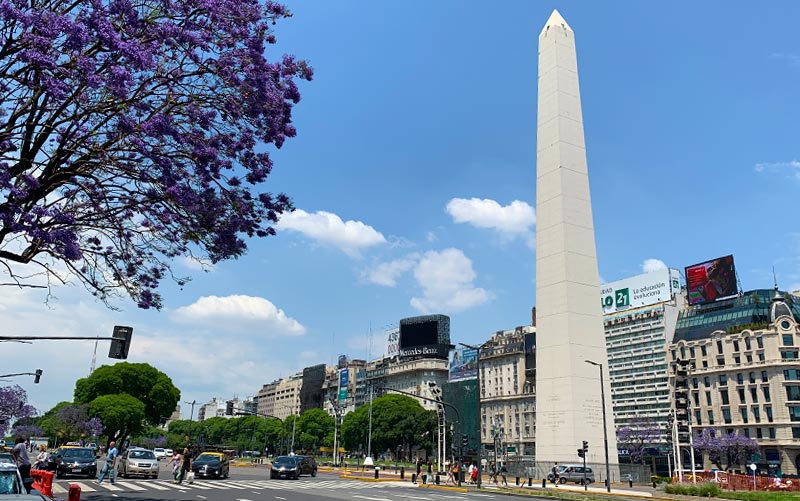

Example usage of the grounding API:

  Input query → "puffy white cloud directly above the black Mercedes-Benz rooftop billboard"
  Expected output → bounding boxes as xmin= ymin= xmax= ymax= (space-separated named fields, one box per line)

xmin=411 ymin=248 xmax=491 ymax=313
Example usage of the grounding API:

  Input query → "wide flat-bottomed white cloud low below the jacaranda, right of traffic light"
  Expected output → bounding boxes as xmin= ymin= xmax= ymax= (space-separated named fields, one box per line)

xmin=172 ymin=295 xmax=306 ymax=336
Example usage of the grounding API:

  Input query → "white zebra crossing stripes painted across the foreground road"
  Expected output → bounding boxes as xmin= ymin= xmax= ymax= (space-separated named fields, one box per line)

xmin=53 ymin=479 xmax=408 ymax=496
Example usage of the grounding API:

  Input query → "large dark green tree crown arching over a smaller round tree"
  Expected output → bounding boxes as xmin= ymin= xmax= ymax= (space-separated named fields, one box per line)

xmin=75 ymin=362 xmax=181 ymax=426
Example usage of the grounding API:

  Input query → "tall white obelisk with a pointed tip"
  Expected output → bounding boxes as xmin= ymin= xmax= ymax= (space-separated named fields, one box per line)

xmin=536 ymin=11 xmax=618 ymax=466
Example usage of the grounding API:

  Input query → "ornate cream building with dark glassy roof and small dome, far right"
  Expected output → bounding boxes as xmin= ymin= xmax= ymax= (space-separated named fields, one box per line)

xmin=669 ymin=286 xmax=800 ymax=475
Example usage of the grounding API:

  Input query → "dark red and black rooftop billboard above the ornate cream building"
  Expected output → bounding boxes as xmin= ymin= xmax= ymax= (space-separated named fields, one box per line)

xmin=686 ymin=255 xmax=739 ymax=305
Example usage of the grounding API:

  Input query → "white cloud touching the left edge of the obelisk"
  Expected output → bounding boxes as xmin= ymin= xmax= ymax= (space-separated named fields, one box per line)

xmin=446 ymin=198 xmax=536 ymax=248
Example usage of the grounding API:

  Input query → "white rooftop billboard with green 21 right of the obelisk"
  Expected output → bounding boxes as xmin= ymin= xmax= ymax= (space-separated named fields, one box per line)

xmin=600 ymin=268 xmax=680 ymax=315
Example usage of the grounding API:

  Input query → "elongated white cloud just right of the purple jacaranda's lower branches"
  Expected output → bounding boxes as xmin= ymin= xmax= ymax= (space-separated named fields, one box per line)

xmin=278 ymin=209 xmax=386 ymax=257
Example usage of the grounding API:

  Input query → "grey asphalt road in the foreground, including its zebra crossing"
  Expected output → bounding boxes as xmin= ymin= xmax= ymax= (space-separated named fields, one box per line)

xmin=53 ymin=463 xmax=499 ymax=501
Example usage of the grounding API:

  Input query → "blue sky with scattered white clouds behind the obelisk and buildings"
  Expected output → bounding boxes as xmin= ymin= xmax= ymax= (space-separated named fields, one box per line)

xmin=0 ymin=1 xmax=800 ymax=417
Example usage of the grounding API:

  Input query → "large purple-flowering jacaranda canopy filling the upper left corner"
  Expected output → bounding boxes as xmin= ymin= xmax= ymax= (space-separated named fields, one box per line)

xmin=0 ymin=0 xmax=312 ymax=308
